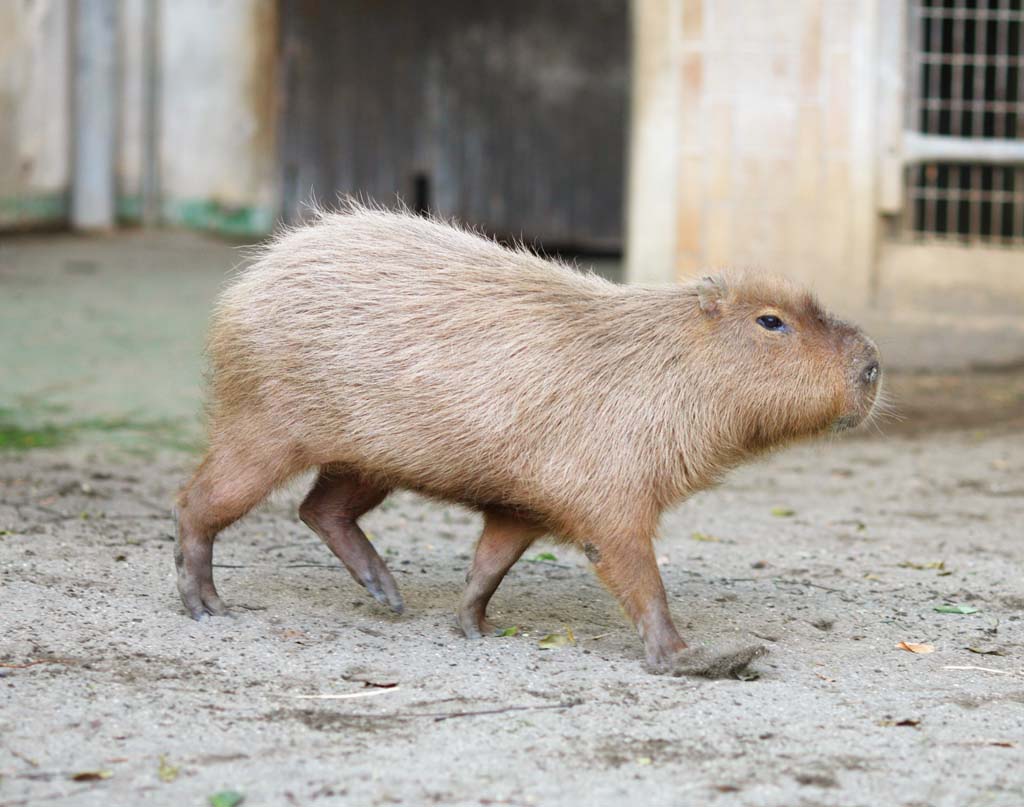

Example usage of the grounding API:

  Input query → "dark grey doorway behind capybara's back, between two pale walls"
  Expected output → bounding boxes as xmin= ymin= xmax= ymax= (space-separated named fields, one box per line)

xmin=280 ymin=0 xmax=629 ymax=252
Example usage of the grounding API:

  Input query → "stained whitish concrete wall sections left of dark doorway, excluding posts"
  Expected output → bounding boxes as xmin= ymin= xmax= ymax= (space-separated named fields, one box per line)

xmin=0 ymin=0 xmax=279 ymax=235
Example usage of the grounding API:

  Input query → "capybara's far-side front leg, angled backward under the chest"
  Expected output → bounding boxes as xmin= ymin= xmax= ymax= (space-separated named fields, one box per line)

xmin=458 ymin=511 xmax=544 ymax=639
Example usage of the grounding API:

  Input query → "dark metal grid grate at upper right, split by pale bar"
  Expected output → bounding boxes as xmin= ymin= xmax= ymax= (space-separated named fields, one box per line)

xmin=905 ymin=0 xmax=1024 ymax=244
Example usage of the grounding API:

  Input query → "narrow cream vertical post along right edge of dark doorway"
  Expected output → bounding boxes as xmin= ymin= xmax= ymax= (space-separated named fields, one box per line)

xmin=626 ymin=0 xmax=687 ymax=283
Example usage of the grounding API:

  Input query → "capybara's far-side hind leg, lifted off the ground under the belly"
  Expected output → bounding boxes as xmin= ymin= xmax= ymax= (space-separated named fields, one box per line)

xmin=299 ymin=467 xmax=404 ymax=613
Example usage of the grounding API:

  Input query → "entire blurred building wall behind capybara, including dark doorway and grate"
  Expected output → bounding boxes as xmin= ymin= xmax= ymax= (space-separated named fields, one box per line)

xmin=0 ymin=0 xmax=1024 ymax=339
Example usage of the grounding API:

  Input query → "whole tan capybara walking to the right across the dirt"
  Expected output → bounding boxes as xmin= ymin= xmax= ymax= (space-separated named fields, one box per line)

xmin=175 ymin=204 xmax=880 ymax=676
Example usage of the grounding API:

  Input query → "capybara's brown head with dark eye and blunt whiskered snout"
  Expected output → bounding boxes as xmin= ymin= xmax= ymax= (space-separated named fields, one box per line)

xmin=694 ymin=273 xmax=882 ymax=450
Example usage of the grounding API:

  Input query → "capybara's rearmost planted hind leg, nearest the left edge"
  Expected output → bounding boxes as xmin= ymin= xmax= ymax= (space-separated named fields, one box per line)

xmin=174 ymin=451 xmax=282 ymax=620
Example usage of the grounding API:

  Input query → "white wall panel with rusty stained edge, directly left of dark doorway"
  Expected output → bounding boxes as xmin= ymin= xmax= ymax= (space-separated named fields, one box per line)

xmin=160 ymin=0 xmax=278 ymax=233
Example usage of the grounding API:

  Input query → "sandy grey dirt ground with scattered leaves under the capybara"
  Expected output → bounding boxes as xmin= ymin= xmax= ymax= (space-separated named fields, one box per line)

xmin=0 ymin=230 xmax=1024 ymax=807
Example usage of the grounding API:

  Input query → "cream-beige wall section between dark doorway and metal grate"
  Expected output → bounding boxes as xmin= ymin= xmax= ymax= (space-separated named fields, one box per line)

xmin=628 ymin=0 xmax=879 ymax=304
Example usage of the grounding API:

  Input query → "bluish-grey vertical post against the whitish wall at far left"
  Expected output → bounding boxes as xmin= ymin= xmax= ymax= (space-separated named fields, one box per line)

xmin=71 ymin=0 xmax=118 ymax=229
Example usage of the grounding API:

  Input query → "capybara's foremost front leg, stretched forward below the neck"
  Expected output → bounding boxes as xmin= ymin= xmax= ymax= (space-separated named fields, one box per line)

xmin=586 ymin=539 xmax=765 ymax=678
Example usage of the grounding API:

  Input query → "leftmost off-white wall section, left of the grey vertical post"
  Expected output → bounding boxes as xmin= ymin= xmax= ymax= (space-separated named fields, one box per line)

xmin=0 ymin=0 xmax=71 ymax=227
